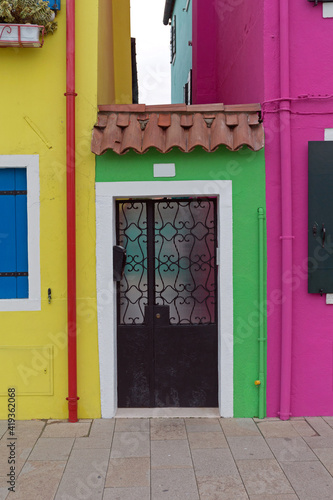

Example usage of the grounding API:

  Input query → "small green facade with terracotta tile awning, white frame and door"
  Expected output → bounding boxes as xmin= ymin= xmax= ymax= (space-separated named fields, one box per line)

xmin=92 ymin=105 xmax=266 ymax=417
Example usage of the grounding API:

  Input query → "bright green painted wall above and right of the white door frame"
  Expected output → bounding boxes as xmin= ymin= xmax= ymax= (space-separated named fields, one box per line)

xmin=96 ymin=147 xmax=266 ymax=417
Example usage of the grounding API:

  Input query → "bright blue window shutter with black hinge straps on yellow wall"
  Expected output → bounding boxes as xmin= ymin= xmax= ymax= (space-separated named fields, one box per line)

xmin=0 ymin=168 xmax=29 ymax=299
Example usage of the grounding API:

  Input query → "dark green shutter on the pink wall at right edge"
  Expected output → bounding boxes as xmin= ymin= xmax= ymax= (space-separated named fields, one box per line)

xmin=308 ymin=141 xmax=333 ymax=293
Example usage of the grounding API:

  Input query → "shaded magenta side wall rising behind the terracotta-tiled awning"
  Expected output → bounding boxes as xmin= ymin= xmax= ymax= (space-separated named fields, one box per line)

xmin=192 ymin=0 xmax=264 ymax=104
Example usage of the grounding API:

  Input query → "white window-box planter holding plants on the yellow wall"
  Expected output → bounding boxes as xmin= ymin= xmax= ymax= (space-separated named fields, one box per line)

xmin=0 ymin=23 xmax=44 ymax=47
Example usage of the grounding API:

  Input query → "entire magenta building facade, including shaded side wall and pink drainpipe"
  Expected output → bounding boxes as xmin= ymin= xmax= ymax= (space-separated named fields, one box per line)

xmin=193 ymin=0 xmax=333 ymax=419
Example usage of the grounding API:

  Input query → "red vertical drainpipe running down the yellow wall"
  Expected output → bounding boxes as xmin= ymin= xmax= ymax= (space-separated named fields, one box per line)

xmin=65 ymin=0 xmax=79 ymax=422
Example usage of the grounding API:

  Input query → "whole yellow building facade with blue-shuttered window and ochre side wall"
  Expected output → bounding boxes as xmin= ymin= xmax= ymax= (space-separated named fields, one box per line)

xmin=0 ymin=0 xmax=131 ymax=419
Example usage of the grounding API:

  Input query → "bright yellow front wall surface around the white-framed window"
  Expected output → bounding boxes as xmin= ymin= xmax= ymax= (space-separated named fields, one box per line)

xmin=0 ymin=0 xmax=100 ymax=419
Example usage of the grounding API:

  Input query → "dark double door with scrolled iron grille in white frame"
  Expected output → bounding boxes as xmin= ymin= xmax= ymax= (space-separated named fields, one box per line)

xmin=117 ymin=198 xmax=218 ymax=408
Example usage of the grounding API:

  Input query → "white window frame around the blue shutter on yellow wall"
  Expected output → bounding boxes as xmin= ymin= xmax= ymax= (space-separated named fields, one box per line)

xmin=0 ymin=155 xmax=41 ymax=311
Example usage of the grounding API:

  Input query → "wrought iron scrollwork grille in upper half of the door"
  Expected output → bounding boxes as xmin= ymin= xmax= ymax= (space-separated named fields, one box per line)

xmin=117 ymin=198 xmax=217 ymax=325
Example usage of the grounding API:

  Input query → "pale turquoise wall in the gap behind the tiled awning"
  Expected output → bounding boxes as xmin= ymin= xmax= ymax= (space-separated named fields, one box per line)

xmin=171 ymin=0 xmax=193 ymax=104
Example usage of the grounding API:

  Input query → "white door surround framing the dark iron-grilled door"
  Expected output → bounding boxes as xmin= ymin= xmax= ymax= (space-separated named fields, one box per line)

xmin=96 ymin=180 xmax=233 ymax=418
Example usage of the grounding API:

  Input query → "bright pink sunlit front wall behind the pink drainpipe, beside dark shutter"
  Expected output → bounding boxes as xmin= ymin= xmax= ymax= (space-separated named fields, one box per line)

xmin=263 ymin=0 xmax=333 ymax=416
